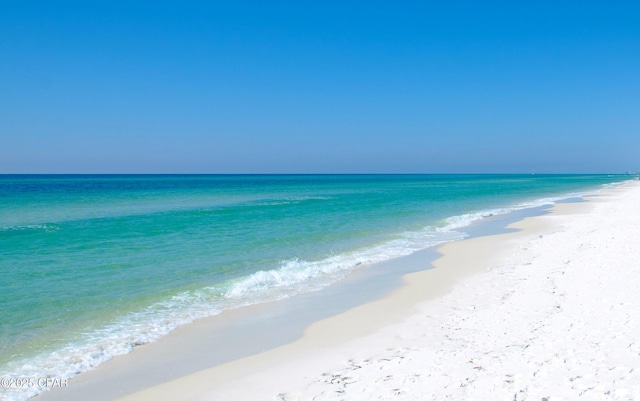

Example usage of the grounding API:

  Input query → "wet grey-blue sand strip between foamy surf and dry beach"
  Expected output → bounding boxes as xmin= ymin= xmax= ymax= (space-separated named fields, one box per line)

xmin=32 ymin=203 xmax=552 ymax=401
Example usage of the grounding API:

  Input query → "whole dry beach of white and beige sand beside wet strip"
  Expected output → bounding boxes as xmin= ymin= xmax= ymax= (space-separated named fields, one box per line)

xmin=42 ymin=182 xmax=640 ymax=401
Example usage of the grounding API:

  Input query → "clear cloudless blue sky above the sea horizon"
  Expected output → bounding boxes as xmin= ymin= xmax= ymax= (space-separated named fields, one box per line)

xmin=0 ymin=0 xmax=640 ymax=173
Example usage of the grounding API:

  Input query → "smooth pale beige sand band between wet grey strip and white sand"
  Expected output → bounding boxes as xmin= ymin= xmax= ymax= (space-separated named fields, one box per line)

xmin=35 ymin=183 xmax=635 ymax=401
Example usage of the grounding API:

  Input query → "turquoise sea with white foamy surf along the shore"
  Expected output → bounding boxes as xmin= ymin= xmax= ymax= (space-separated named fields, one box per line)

xmin=0 ymin=175 xmax=631 ymax=400
